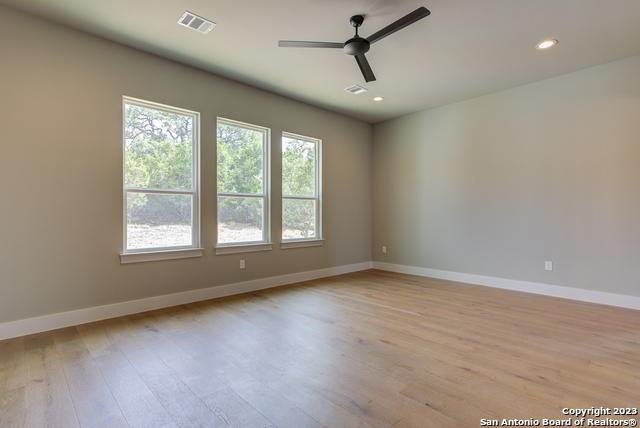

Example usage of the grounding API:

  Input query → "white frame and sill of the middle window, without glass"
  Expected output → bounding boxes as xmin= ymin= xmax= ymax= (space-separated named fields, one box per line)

xmin=215 ymin=117 xmax=272 ymax=254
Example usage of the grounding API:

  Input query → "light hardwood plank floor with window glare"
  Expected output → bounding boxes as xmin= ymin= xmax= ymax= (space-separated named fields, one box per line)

xmin=0 ymin=271 xmax=640 ymax=428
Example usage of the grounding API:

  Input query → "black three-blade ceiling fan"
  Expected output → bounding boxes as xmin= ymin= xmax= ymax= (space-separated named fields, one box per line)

xmin=278 ymin=7 xmax=431 ymax=82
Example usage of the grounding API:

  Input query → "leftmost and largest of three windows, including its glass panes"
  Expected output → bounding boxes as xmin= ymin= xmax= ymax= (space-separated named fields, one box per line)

xmin=123 ymin=97 xmax=200 ymax=253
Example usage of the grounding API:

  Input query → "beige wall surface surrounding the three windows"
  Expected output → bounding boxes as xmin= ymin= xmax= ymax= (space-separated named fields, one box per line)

xmin=0 ymin=7 xmax=372 ymax=322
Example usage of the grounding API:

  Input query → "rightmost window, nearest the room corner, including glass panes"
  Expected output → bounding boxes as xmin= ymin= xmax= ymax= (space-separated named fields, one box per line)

xmin=282 ymin=132 xmax=322 ymax=241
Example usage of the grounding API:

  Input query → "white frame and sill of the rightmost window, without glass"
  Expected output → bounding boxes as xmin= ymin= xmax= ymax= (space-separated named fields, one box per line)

xmin=280 ymin=131 xmax=324 ymax=249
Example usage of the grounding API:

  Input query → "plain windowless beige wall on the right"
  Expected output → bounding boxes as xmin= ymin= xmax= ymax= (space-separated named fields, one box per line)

xmin=373 ymin=57 xmax=640 ymax=296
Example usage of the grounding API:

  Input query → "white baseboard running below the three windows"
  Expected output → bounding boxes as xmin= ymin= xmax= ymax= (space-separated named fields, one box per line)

xmin=0 ymin=262 xmax=372 ymax=340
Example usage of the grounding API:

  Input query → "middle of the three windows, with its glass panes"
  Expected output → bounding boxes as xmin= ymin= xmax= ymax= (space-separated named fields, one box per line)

xmin=217 ymin=118 xmax=271 ymax=247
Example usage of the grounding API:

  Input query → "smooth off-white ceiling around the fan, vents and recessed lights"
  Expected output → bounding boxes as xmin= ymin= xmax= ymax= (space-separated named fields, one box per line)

xmin=0 ymin=0 xmax=640 ymax=122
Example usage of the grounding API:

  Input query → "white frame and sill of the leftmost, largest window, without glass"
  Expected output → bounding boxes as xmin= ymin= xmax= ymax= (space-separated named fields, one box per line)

xmin=121 ymin=96 xmax=203 ymax=263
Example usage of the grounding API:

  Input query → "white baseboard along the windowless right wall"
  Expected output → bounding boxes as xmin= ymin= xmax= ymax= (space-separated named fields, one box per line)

xmin=373 ymin=262 xmax=640 ymax=310
